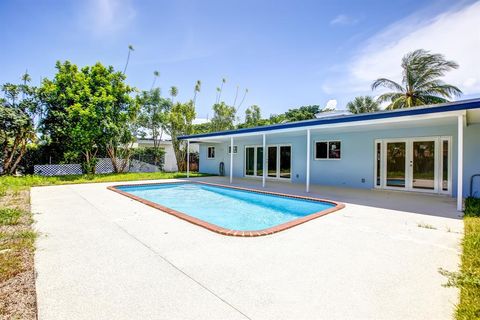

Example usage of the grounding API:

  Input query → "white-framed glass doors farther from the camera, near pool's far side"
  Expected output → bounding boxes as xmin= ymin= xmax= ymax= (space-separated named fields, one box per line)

xmin=245 ymin=145 xmax=292 ymax=179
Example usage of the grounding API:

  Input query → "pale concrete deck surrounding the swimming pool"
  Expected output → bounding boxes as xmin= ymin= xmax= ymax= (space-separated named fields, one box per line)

xmin=31 ymin=177 xmax=463 ymax=319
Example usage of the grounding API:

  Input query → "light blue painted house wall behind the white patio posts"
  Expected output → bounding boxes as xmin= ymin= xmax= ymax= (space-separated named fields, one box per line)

xmin=199 ymin=124 xmax=480 ymax=196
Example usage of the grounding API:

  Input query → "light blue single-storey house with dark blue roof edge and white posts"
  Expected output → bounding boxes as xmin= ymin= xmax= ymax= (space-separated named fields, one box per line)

xmin=181 ymin=99 xmax=480 ymax=210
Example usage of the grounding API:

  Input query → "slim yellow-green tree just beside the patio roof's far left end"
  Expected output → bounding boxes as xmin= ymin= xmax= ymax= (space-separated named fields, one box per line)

xmin=165 ymin=100 xmax=196 ymax=171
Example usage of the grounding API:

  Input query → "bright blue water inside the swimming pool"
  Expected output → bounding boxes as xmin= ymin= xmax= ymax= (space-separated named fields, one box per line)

xmin=117 ymin=183 xmax=335 ymax=231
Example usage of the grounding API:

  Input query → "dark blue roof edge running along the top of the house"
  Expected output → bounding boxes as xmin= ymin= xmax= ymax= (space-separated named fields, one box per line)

xmin=179 ymin=98 xmax=480 ymax=140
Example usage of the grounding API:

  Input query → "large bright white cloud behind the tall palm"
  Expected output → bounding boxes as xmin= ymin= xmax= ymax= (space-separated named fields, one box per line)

xmin=322 ymin=2 xmax=480 ymax=95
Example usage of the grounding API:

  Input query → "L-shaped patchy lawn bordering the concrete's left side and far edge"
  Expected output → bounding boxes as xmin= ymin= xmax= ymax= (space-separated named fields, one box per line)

xmin=0 ymin=172 xmax=210 ymax=319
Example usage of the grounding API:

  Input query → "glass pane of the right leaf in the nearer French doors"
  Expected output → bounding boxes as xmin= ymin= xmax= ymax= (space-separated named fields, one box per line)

xmin=410 ymin=140 xmax=436 ymax=190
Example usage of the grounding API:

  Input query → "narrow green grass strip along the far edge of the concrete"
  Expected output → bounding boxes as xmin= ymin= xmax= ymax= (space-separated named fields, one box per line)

xmin=0 ymin=172 xmax=207 ymax=196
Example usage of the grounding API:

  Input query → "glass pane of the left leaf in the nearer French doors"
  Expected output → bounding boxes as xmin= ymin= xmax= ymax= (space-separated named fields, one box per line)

xmin=385 ymin=142 xmax=407 ymax=188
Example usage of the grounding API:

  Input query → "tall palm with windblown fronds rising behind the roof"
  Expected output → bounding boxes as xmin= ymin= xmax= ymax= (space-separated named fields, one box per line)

xmin=372 ymin=49 xmax=462 ymax=109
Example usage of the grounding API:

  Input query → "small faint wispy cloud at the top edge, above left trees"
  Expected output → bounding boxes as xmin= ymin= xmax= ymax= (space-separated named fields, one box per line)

xmin=80 ymin=0 xmax=136 ymax=35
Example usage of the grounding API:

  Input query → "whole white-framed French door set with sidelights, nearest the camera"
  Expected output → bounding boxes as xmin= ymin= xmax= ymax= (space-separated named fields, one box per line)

xmin=375 ymin=137 xmax=451 ymax=193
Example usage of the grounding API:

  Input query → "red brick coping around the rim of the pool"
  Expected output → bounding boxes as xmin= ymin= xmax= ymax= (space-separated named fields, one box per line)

xmin=107 ymin=181 xmax=345 ymax=237
